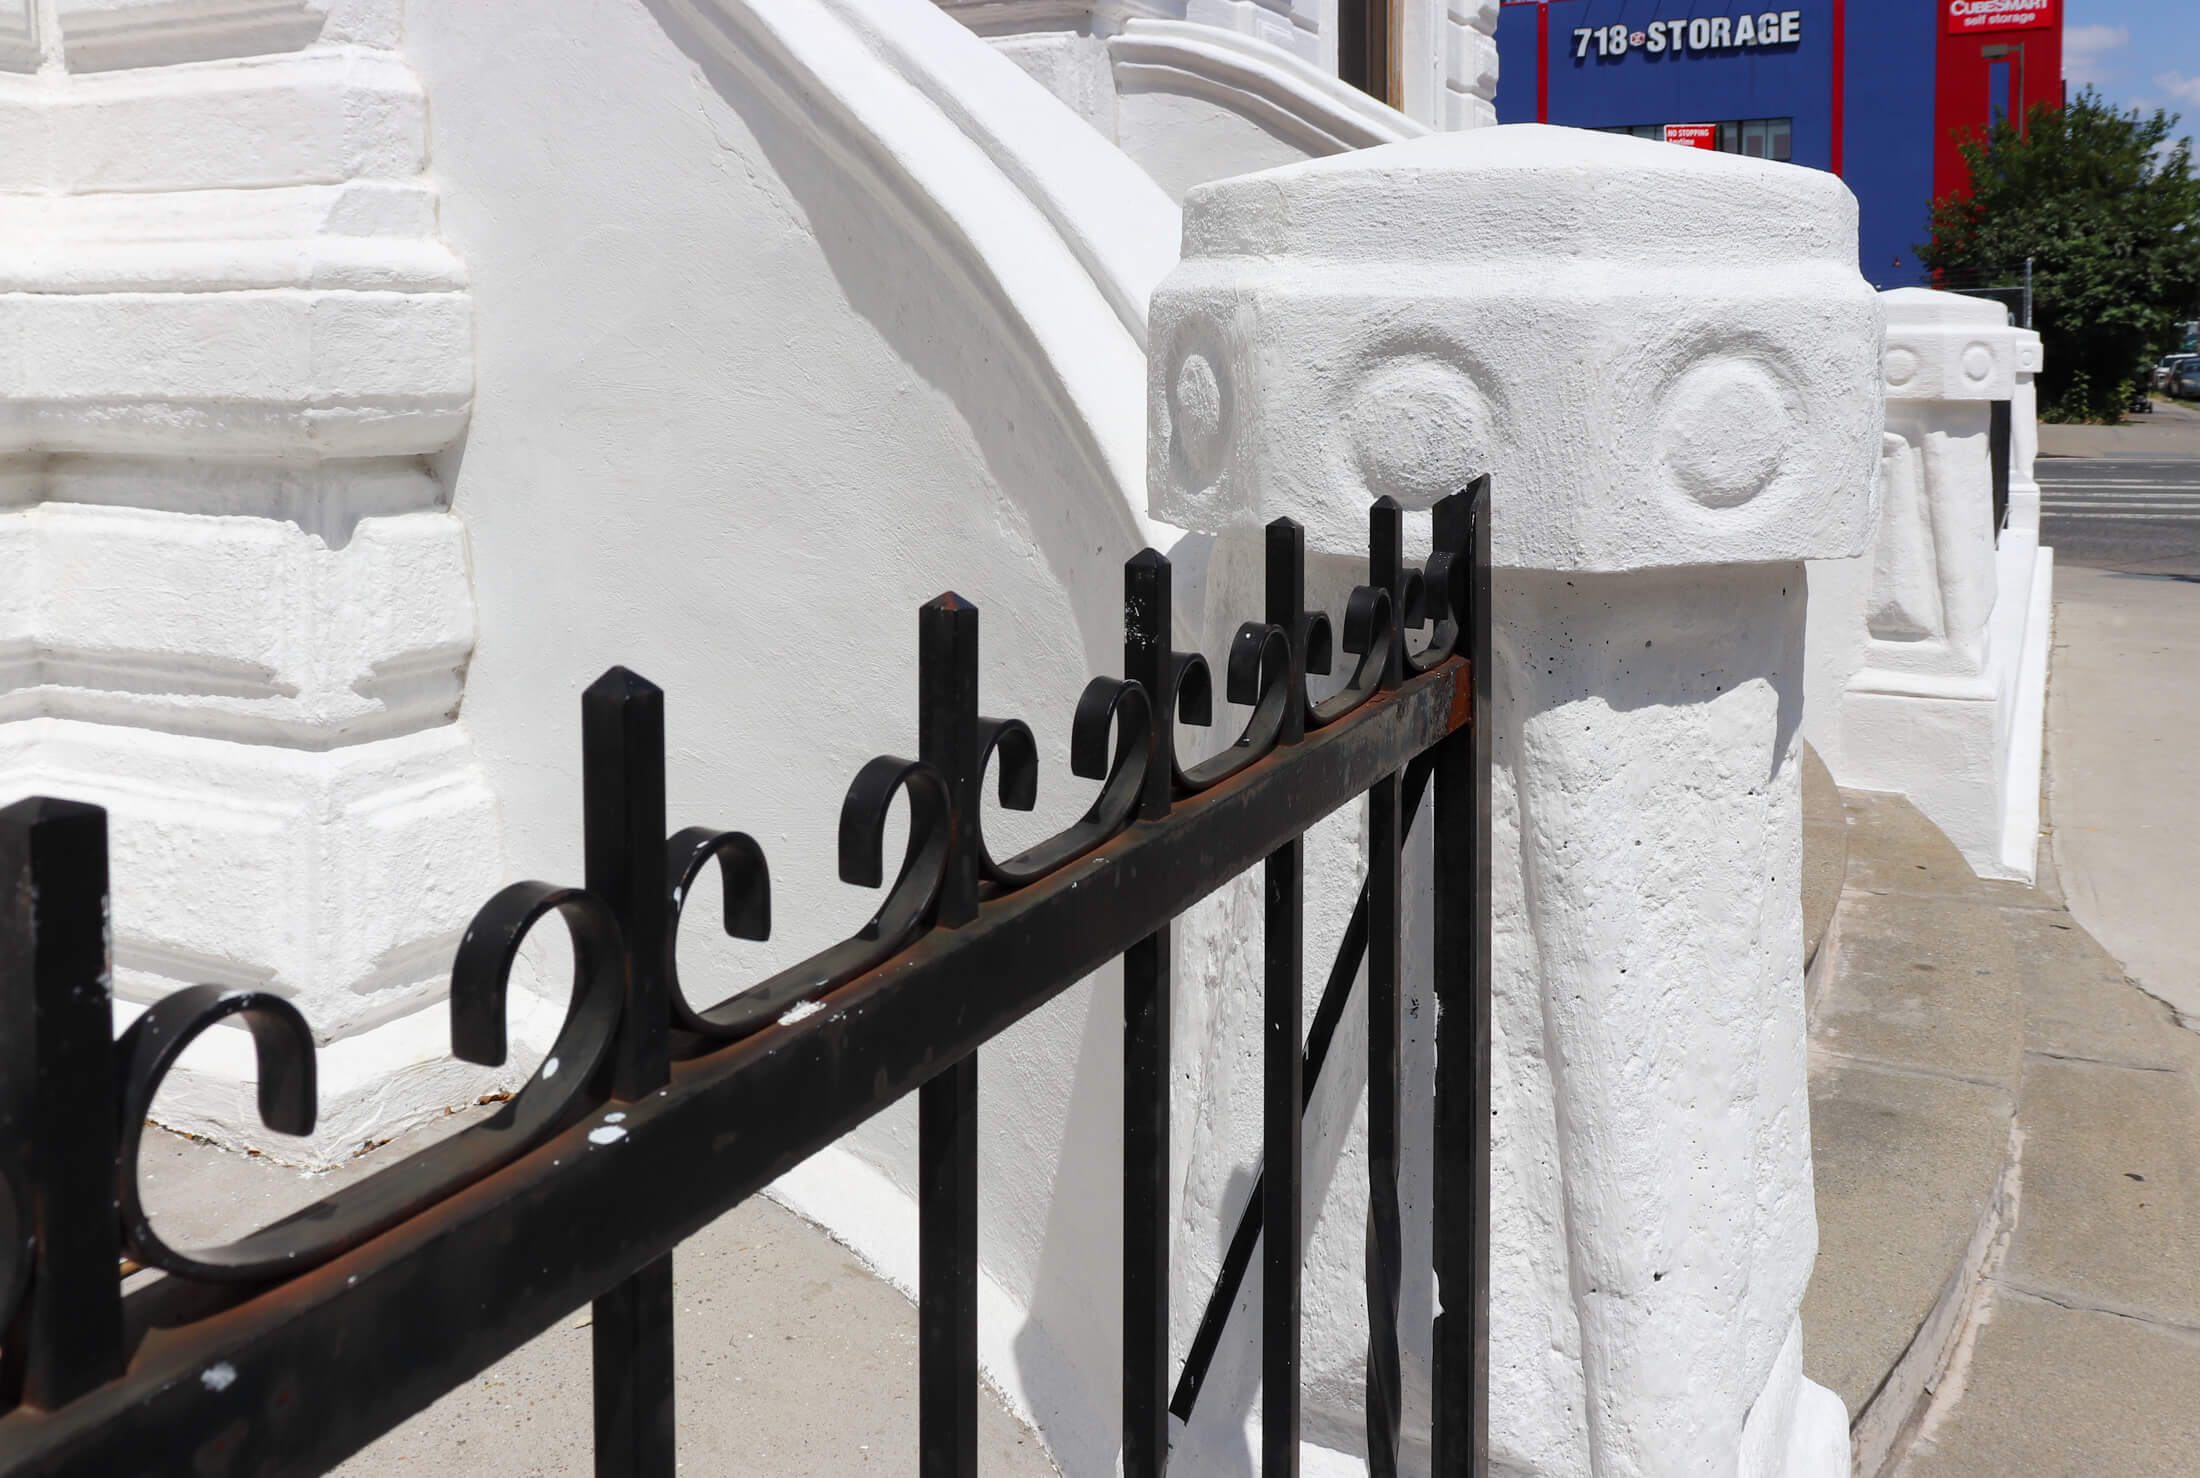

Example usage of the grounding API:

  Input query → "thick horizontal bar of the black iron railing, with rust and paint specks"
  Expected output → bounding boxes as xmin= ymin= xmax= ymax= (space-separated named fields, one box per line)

xmin=0 ymin=660 xmax=1472 ymax=1478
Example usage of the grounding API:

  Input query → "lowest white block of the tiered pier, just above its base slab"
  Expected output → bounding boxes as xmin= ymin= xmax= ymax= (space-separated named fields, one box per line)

xmin=0 ymin=717 xmax=504 ymax=1038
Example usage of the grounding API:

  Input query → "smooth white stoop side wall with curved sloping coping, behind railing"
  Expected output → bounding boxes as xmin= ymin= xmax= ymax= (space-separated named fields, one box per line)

xmin=407 ymin=0 xmax=1197 ymax=1474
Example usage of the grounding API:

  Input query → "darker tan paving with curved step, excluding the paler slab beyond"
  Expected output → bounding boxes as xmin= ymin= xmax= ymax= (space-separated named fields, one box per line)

xmin=1802 ymin=792 xmax=2200 ymax=1478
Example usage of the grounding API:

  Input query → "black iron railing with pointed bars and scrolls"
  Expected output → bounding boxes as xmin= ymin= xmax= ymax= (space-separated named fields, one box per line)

xmin=0 ymin=482 xmax=1489 ymax=1478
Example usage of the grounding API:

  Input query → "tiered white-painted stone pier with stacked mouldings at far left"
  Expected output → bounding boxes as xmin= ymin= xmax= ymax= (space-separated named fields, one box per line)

xmin=0 ymin=0 xmax=502 ymax=1163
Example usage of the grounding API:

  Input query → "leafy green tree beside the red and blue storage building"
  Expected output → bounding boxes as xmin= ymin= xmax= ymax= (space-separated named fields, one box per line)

xmin=1916 ymin=88 xmax=2200 ymax=422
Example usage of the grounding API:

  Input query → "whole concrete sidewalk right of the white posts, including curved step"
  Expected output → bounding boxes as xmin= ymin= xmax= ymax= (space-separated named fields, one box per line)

xmin=1804 ymin=501 xmax=2200 ymax=1478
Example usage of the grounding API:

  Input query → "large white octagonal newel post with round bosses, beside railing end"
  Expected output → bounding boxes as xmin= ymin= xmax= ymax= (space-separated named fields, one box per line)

xmin=1148 ymin=128 xmax=1881 ymax=1478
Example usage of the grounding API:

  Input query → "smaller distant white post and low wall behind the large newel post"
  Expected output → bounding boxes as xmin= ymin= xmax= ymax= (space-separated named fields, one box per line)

xmin=1806 ymin=288 xmax=2053 ymax=880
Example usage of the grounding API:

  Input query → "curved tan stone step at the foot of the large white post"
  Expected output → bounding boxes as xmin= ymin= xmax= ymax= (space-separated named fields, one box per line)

xmin=1802 ymin=792 xmax=2039 ymax=1476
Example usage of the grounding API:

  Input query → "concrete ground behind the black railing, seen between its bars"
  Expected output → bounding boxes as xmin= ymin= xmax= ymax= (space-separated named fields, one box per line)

xmin=139 ymin=1130 xmax=1054 ymax=1478
